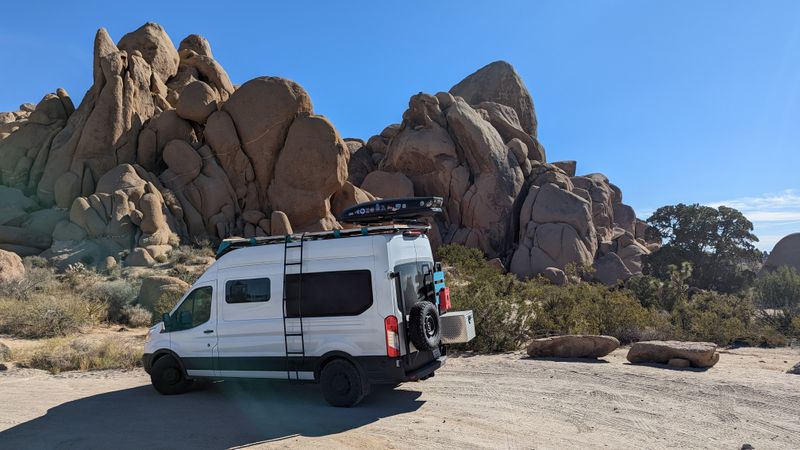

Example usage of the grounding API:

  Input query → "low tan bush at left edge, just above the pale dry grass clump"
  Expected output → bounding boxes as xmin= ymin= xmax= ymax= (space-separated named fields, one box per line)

xmin=0 ymin=293 xmax=106 ymax=338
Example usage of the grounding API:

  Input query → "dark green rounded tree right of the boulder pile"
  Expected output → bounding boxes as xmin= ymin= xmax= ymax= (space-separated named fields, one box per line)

xmin=643 ymin=203 xmax=762 ymax=293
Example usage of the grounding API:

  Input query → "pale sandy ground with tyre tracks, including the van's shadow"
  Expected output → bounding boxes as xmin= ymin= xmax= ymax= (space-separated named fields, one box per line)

xmin=0 ymin=348 xmax=800 ymax=450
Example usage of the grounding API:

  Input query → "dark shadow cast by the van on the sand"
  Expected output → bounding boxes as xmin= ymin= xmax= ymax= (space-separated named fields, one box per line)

xmin=0 ymin=381 xmax=425 ymax=449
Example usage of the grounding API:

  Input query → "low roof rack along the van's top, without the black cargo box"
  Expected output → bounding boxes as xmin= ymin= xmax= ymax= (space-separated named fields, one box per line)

xmin=216 ymin=224 xmax=431 ymax=259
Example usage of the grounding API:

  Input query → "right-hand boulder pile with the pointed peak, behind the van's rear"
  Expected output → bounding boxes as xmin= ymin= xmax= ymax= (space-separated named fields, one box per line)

xmin=360 ymin=61 xmax=657 ymax=284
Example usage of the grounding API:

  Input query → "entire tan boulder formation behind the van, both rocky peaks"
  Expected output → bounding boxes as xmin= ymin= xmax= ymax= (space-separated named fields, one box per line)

xmin=0 ymin=23 xmax=657 ymax=284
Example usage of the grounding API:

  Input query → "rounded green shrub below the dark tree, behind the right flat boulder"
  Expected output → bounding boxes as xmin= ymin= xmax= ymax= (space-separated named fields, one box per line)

xmin=672 ymin=291 xmax=755 ymax=345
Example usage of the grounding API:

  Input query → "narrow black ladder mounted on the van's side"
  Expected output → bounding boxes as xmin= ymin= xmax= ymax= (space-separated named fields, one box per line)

xmin=283 ymin=233 xmax=306 ymax=381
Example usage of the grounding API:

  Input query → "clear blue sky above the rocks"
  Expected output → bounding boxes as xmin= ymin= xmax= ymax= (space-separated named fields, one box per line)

xmin=0 ymin=0 xmax=800 ymax=250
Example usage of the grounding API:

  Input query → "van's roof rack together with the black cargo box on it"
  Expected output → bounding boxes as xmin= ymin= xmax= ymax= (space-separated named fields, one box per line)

xmin=216 ymin=197 xmax=442 ymax=259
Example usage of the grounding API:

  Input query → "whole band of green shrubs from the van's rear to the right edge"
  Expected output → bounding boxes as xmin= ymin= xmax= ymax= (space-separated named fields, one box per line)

xmin=438 ymin=245 xmax=800 ymax=352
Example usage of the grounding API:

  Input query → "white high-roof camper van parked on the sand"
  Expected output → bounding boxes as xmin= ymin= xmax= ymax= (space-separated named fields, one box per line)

xmin=144 ymin=198 xmax=475 ymax=406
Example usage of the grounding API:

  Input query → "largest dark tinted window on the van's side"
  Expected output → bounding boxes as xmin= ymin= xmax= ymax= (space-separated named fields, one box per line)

xmin=286 ymin=270 xmax=372 ymax=317
